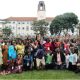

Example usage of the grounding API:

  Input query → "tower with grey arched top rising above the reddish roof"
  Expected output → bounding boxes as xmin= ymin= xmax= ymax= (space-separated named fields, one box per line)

xmin=37 ymin=1 xmax=46 ymax=20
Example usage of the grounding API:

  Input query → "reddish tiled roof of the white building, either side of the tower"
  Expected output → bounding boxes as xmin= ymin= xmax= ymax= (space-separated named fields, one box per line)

xmin=4 ymin=17 xmax=53 ymax=21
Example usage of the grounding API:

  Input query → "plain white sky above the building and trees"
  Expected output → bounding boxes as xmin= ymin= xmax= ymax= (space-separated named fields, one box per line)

xmin=0 ymin=0 xmax=80 ymax=19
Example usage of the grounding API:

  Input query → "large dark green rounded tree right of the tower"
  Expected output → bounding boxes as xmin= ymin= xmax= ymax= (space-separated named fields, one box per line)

xmin=50 ymin=13 xmax=79 ymax=34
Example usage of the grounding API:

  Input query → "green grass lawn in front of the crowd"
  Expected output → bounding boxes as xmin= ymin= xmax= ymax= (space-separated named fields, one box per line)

xmin=0 ymin=70 xmax=80 ymax=80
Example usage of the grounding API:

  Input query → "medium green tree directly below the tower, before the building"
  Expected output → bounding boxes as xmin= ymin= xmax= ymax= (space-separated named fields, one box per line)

xmin=32 ymin=20 xmax=48 ymax=36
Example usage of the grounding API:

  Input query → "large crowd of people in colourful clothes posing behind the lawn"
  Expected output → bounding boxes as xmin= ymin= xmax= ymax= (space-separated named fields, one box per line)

xmin=0 ymin=36 xmax=80 ymax=75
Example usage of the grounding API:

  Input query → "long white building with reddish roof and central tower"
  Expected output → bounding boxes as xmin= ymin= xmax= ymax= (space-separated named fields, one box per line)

xmin=2 ymin=1 xmax=53 ymax=36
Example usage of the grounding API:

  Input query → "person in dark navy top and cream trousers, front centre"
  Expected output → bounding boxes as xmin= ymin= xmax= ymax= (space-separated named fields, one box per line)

xmin=36 ymin=41 xmax=45 ymax=69
